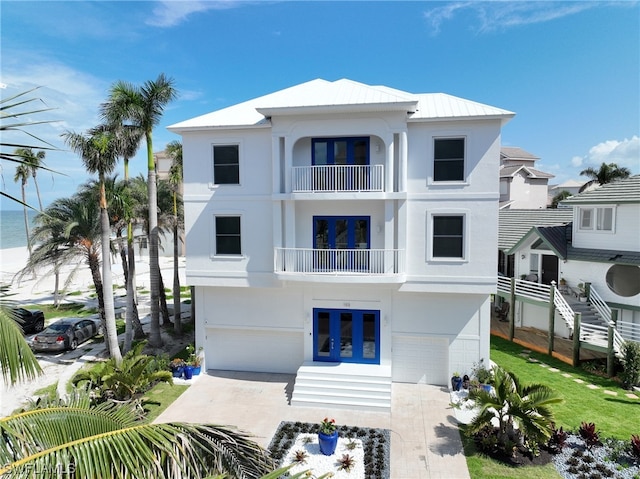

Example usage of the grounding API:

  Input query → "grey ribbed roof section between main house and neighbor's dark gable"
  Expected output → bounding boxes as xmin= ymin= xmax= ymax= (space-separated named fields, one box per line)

xmin=498 ymin=208 xmax=573 ymax=251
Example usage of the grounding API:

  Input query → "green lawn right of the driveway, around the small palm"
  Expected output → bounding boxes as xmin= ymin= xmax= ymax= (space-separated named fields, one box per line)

xmin=461 ymin=336 xmax=640 ymax=479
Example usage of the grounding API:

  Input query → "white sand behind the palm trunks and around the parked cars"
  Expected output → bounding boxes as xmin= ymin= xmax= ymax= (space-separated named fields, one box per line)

xmin=0 ymin=247 xmax=186 ymax=417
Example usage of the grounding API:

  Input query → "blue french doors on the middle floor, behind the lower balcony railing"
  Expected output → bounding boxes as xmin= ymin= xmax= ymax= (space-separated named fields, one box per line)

xmin=313 ymin=216 xmax=371 ymax=272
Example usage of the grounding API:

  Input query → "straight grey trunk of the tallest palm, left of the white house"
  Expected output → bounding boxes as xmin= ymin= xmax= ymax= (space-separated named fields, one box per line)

xmin=147 ymin=139 xmax=162 ymax=348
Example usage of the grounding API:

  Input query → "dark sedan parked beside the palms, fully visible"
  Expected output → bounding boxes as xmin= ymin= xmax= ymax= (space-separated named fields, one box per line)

xmin=31 ymin=318 xmax=100 ymax=351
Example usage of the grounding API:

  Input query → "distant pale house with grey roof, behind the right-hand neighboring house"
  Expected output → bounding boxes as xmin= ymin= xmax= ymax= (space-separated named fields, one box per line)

xmin=500 ymin=146 xmax=553 ymax=210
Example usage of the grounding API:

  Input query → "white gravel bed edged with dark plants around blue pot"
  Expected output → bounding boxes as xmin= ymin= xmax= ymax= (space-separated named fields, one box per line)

xmin=268 ymin=421 xmax=391 ymax=479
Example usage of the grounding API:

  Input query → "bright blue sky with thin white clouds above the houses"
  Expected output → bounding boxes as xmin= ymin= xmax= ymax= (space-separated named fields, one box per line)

xmin=0 ymin=0 xmax=640 ymax=209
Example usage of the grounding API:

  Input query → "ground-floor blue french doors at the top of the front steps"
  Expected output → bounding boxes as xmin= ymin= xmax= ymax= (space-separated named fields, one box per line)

xmin=313 ymin=308 xmax=380 ymax=364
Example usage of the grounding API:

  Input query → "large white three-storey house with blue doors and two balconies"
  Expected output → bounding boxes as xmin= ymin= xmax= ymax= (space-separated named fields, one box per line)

xmin=169 ymin=79 xmax=514 ymax=409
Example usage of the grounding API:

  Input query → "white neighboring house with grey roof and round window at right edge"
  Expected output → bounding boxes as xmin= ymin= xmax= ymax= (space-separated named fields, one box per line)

xmin=501 ymin=176 xmax=640 ymax=341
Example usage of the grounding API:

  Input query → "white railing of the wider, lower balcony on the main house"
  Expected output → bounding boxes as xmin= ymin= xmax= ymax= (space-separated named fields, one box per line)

xmin=274 ymin=248 xmax=405 ymax=282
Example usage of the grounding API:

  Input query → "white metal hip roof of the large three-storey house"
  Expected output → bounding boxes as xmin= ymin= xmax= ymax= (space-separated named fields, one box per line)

xmin=169 ymin=79 xmax=515 ymax=131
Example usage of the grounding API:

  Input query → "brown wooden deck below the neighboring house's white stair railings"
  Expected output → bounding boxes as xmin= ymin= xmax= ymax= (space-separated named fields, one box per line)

xmin=491 ymin=313 xmax=607 ymax=364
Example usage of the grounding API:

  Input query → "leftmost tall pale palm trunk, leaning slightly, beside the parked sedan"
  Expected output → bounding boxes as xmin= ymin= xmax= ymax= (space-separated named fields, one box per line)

xmin=100 ymin=180 xmax=122 ymax=365
